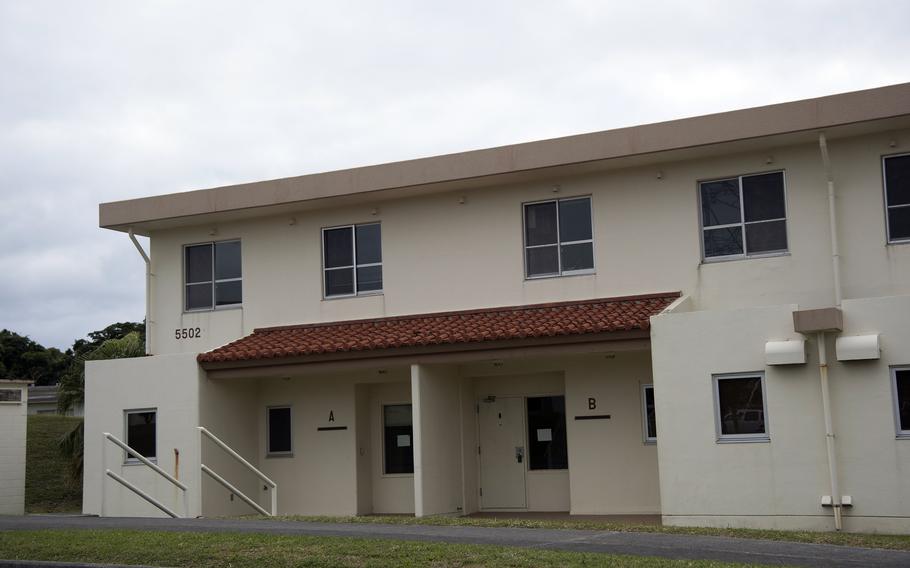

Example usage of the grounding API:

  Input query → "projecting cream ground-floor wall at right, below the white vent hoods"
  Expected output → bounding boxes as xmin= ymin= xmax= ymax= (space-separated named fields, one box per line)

xmin=652 ymin=297 xmax=910 ymax=532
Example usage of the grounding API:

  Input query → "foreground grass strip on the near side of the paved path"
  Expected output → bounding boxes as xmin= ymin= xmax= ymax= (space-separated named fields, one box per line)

xmin=0 ymin=530 xmax=772 ymax=568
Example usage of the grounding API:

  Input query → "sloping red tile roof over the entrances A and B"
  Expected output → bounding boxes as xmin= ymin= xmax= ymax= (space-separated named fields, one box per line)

xmin=197 ymin=292 xmax=679 ymax=363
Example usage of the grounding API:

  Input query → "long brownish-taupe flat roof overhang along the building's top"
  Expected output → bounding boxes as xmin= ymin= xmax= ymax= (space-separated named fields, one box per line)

xmin=99 ymin=83 xmax=910 ymax=235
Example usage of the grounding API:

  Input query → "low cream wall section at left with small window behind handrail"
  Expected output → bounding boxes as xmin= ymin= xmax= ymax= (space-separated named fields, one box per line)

xmin=82 ymin=354 xmax=202 ymax=517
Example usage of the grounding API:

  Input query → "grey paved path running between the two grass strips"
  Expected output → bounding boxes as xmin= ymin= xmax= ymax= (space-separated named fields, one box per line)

xmin=0 ymin=515 xmax=910 ymax=568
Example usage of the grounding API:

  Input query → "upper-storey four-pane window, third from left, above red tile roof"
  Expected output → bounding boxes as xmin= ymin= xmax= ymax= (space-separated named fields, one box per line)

xmin=524 ymin=197 xmax=594 ymax=278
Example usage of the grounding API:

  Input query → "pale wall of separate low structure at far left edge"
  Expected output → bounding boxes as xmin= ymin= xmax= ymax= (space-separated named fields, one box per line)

xmin=0 ymin=381 xmax=28 ymax=515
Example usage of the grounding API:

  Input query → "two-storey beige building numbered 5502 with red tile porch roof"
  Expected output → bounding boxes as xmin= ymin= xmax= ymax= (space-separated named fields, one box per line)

xmin=84 ymin=84 xmax=910 ymax=532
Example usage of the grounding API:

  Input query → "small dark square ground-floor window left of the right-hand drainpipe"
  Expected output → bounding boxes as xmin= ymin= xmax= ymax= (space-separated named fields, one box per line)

xmin=714 ymin=373 xmax=769 ymax=442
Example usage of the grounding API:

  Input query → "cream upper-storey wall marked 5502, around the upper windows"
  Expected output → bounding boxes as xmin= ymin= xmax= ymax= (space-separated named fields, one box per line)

xmin=151 ymin=133 xmax=910 ymax=358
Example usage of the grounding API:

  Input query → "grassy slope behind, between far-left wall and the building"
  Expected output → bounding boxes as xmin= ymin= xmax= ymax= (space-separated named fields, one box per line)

xmin=25 ymin=414 xmax=82 ymax=513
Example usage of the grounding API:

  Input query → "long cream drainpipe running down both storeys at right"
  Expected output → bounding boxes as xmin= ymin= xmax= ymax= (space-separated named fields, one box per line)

xmin=816 ymin=132 xmax=843 ymax=531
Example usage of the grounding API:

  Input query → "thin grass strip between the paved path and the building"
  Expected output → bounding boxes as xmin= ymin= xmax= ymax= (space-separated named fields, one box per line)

xmin=279 ymin=516 xmax=910 ymax=550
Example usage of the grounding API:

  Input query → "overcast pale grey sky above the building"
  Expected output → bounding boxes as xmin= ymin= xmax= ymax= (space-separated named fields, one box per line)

xmin=0 ymin=0 xmax=910 ymax=348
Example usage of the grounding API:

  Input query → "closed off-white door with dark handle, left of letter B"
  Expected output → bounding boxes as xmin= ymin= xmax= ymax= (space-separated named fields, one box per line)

xmin=478 ymin=397 xmax=528 ymax=509
